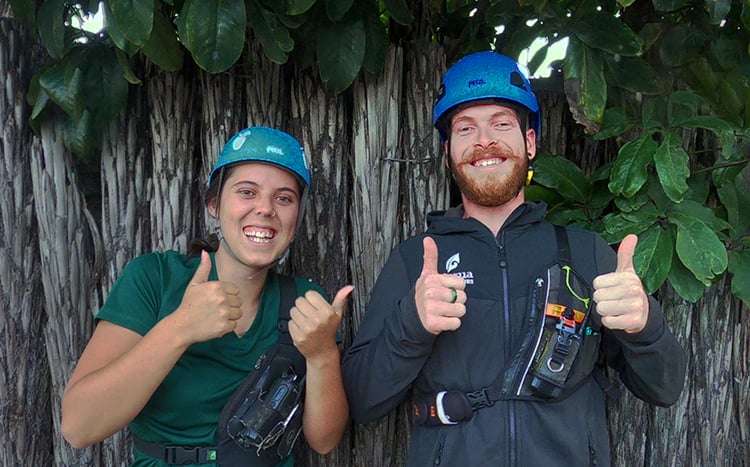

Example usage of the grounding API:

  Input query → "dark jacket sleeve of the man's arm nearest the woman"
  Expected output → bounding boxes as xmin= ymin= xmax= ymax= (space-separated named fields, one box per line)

xmin=342 ymin=249 xmax=435 ymax=424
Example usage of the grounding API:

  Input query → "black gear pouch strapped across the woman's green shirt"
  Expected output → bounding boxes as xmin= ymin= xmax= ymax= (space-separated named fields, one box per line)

xmin=216 ymin=348 xmax=305 ymax=467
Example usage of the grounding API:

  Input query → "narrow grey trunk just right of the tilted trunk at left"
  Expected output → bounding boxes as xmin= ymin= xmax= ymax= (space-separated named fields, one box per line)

xmin=97 ymin=82 xmax=155 ymax=467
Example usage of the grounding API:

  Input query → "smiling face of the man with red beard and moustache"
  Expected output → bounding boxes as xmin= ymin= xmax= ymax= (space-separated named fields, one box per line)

xmin=446 ymin=104 xmax=536 ymax=207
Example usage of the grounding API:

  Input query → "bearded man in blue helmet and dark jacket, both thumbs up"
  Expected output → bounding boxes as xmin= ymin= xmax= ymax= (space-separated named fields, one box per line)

xmin=343 ymin=52 xmax=685 ymax=466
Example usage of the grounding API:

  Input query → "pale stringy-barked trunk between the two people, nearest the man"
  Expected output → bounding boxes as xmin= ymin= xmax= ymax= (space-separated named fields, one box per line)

xmin=351 ymin=47 xmax=408 ymax=467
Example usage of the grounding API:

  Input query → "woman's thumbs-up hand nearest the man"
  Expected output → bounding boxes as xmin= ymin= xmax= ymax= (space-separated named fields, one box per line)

xmin=289 ymin=285 xmax=354 ymax=361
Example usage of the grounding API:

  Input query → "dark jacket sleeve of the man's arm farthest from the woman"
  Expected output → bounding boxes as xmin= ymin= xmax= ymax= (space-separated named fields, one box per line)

xmin=597 ymin=236 xmax=687 ymax=407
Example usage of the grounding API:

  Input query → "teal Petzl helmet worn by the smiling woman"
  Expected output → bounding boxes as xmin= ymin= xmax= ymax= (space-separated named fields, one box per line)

xmin=208 ymin=126 xmax=310 ymax=192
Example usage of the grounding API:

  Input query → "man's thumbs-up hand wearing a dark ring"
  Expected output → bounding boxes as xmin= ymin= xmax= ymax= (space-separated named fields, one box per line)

xmin=414 ymin=237 xmax=466 ymax=334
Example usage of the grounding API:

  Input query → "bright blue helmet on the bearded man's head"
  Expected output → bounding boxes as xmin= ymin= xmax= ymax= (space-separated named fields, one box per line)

xmin=432 ymin=52 xmax=541 ymax=141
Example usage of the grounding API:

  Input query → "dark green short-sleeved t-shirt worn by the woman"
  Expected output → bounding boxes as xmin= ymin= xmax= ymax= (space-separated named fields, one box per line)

xmin=96 ymin=251 xmax=324 ymax=467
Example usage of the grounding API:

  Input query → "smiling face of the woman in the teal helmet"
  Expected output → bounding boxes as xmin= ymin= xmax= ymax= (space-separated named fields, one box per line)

xmin=208 ymin=162 xmax=301 ymax=269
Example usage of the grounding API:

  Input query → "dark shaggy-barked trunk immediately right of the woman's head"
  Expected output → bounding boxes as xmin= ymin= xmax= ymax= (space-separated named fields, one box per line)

xmin=284 ymin=65 xmax=351 ymax=466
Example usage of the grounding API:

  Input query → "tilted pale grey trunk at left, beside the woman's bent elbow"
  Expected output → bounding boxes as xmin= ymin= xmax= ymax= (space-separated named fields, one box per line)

xmin=31 ymin=124 xmax=100 ymax=466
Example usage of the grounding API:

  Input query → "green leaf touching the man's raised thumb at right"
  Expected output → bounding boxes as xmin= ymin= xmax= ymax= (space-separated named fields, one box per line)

xmin=633 ymin=224 xmax=674 ymax=293
